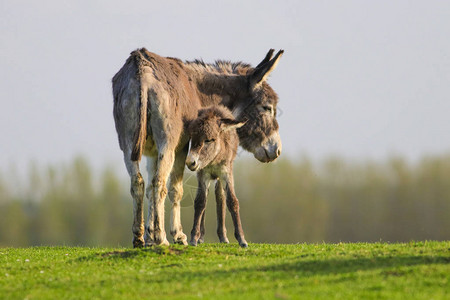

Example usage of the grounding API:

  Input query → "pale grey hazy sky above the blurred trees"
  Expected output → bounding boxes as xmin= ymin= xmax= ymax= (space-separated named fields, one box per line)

xmin=0 ymin=0 xmax=450 ymax=172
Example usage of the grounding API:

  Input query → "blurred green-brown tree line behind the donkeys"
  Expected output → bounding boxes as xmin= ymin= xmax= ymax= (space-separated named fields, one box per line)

xmin=0 ymin=155 xmax=450 ymax=246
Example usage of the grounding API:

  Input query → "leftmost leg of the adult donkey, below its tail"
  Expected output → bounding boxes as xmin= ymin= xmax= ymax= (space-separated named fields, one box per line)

xmin=125 ymin=155 xmax=145 ymax=248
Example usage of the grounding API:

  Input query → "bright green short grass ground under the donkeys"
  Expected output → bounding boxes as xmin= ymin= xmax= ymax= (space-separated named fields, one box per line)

xmin=0 ymin=242 xmax=450 ymax=299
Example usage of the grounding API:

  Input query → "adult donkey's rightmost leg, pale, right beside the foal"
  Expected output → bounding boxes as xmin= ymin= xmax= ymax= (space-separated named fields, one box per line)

xmin=169 ymin=144 xmax=189 ymax=245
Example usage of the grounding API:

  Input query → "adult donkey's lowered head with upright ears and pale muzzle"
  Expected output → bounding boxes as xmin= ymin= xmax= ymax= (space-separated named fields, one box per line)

xmin=233 ymin=49 xmax=284 ymax=162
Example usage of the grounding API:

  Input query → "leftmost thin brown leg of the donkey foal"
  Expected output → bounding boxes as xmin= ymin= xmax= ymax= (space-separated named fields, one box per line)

xmin=189 ymin=171 xmax=210 ymax=246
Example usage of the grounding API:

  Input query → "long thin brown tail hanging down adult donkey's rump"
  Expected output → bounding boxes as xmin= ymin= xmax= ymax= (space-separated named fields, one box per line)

xmin=131 ymin=78 xmax=148 ymax=161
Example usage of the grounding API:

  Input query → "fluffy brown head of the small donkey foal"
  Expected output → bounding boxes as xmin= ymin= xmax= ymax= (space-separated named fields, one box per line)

xmin=186 ymin=106 xmax=244 ymax=171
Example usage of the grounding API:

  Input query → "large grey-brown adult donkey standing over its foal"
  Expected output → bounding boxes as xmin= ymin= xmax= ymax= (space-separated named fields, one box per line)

xmin=112 ymin=48 xmax=283 ymax=247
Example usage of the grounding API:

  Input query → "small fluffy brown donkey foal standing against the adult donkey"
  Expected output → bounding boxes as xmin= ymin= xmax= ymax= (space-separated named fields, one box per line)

xmin=186 ymin=105 xmax=248 ymax=247
